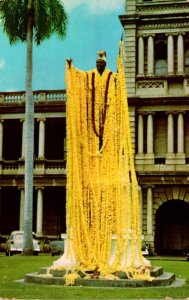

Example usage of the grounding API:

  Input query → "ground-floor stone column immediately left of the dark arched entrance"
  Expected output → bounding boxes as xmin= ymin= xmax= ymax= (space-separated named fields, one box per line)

xmin=147 ymin=186 xmax=153 ymax=236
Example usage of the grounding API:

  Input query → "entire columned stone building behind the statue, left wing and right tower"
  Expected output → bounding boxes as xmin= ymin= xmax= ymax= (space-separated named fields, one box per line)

xmin=0 ymin=0 xmax=189 ymax=254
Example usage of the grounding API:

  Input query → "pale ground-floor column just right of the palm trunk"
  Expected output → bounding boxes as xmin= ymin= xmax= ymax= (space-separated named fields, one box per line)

xmin=36 ymin=187 xmax=43 ymax=235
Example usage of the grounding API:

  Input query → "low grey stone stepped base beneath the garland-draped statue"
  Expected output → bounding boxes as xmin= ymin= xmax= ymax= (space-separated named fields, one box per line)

xmin=25 ymin=267 xmax=175 ymax=288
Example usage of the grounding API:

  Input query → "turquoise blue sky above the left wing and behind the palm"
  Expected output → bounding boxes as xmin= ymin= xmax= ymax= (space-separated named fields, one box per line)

xmin=0 ymin=0 xmax=125 ymax=92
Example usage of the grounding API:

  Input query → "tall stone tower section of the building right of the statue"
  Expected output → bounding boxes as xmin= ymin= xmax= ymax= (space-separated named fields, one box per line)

xmin=120 ymin=0 xmax=189 ymax=254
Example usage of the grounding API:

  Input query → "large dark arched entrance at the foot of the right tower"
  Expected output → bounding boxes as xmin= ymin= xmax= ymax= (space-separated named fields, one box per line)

xmin=155 ymin=200 xmax=189 ymax=254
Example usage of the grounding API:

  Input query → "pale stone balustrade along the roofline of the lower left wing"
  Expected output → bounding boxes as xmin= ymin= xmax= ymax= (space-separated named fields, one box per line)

xmin=0 ymin=90 xmax=66 ymax=103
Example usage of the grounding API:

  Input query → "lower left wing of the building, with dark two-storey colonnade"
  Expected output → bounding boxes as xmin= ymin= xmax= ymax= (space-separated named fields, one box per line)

xmin=0 ymin=90 xmax=66 ymax=236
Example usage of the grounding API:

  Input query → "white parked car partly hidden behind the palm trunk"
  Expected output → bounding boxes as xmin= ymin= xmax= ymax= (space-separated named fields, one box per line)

xmin=5 ymin=230 xmax=40 ymax=256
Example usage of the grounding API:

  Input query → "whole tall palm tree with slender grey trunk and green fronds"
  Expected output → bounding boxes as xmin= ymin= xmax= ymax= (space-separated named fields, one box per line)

xmin=0 ymin=0 xmax=68 ymax=255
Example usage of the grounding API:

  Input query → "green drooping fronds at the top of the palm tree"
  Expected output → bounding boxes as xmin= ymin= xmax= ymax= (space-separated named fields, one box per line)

xmin=0 ymin=0 xmax=68 ymax=45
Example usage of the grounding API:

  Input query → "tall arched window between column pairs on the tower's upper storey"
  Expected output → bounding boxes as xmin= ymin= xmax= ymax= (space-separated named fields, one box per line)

xmin=155 ymin=40 xmax=167 ymax=76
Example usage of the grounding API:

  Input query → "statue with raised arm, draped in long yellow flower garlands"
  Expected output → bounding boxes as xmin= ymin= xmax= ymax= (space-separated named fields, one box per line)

xmin=53 ymin=44 xmax=150 ymax=280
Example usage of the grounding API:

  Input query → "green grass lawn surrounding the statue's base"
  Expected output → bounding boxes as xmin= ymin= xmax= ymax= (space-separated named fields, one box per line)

xmin=0 ymin=254 xmax=189 ymax=300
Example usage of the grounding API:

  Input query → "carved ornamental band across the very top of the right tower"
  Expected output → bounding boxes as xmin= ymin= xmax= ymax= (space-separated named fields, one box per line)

xmin=137 ymin=4 xmax=189 ymax=14
